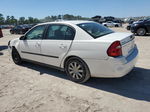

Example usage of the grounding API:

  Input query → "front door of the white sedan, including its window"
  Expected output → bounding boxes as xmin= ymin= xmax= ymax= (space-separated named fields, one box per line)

xmin=20 ymin=25 xmax=46 ymax=62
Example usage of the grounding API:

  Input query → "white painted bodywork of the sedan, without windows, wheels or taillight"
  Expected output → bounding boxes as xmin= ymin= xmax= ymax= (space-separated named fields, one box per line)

xmin=9 ymin=21 xmax=138 ymax=80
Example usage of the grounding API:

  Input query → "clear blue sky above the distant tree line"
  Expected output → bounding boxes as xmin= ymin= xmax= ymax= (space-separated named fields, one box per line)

xmin=0 ymin=0 xmax=150 ymax=19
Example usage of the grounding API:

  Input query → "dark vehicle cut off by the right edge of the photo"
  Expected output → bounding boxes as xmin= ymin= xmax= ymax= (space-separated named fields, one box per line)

xmin=131 ymin=19 xmax=150 ymax=36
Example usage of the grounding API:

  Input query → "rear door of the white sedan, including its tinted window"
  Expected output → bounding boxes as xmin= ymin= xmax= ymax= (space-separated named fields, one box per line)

xmin=41 ymin=24 xmax=75 ymax=67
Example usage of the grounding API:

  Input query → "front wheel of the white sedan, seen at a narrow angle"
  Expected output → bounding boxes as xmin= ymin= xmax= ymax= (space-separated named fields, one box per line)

xmin=12 ymin=48 xmax=22 ymax=65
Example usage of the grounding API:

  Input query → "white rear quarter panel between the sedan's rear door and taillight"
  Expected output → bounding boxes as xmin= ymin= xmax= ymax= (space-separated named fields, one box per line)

xmin=63 ymin=39 xmax=110 ymax=60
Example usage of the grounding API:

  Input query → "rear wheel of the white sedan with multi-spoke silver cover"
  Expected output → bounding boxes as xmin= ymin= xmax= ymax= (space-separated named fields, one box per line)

xmin=65 ymin=57 xmax=91 ymax=83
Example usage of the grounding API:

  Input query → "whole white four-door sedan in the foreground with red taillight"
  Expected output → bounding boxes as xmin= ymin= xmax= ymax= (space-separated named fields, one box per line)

xmin=8 ymin=21 xmax=138 ymax=83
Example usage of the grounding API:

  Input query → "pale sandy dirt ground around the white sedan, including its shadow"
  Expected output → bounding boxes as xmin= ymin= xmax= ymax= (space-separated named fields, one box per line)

xmin=0 ymin=25 xmax=150 ymax=112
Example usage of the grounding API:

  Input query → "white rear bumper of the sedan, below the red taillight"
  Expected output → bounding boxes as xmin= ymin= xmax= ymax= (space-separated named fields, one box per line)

xmin=84 ymin=47 xmax=138 ymax=78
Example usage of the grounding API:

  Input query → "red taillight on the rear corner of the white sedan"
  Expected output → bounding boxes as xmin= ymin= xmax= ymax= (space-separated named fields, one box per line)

xmin=107 ymin=41 xmax=122 ymax=57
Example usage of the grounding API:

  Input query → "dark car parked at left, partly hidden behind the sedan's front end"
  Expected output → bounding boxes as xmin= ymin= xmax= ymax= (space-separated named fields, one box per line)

xmin=10 ymin=25 xmax=34 ymax=34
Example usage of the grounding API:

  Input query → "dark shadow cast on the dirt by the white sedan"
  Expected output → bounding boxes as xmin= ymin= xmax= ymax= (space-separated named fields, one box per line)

xmin=20 ymin=62 xmax=150 ymax=102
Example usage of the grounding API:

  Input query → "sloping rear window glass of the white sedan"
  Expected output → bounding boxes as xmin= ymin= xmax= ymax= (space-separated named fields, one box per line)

xmin=78 ymin=22 xmax=114 ymax=39
